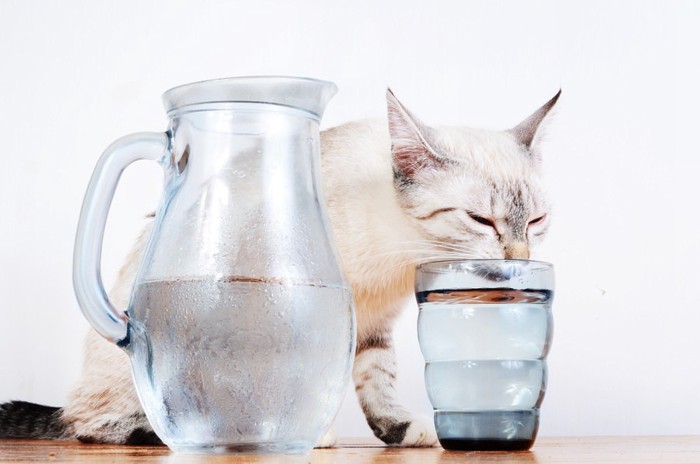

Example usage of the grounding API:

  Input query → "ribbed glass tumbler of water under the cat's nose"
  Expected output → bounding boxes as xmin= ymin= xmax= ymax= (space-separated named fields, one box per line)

xmin=416 ymin=260 xmax=554 ymax=450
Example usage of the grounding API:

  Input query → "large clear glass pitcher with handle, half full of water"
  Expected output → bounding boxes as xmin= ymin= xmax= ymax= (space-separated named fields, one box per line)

xmin=73 ymin=77 xmax=355 ymax=452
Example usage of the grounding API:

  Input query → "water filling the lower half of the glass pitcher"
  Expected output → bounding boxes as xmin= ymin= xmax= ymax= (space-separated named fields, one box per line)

xmin=124 ymin=277 xmax=353 ymax=452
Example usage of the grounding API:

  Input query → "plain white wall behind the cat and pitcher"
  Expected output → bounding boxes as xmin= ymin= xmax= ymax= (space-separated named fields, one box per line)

xmin=0 ymin=0 xmax=700 ymax=435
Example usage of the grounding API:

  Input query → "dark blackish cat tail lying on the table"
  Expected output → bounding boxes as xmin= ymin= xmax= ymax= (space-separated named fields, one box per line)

xmin=0 ymin=401 xmax=66 ymax=440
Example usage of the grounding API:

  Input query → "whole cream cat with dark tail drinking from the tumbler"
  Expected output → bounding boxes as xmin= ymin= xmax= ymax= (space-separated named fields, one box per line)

xmin=0 ymin=86 xmax=561 ymax=446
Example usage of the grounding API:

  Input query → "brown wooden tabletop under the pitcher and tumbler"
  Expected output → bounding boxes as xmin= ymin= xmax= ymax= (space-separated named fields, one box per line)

xmin=0 ymin=436 xmax=700 ymax=464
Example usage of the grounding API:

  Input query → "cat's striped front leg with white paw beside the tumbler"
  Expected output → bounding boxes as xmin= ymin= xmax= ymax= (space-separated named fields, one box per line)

xmin=352 ymin=333 xmax=437 ymax=446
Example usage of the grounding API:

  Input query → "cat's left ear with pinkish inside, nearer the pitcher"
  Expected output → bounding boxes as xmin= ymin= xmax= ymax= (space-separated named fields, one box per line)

xmin=386 ymin=89 xmax=449 ymax=181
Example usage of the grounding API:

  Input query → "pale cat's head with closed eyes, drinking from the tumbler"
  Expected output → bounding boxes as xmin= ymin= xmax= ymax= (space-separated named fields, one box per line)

xmin=387 ymin=90 xmax=561 ymax=259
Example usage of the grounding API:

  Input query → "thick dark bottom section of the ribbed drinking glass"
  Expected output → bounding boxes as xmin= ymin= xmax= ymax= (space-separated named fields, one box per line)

xmin=435 ymin=409 xmax=540 ymax=451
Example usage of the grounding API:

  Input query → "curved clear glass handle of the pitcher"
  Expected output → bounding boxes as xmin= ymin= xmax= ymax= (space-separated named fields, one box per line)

xmin=73 ymin=132 xmax=170 ymax=344
